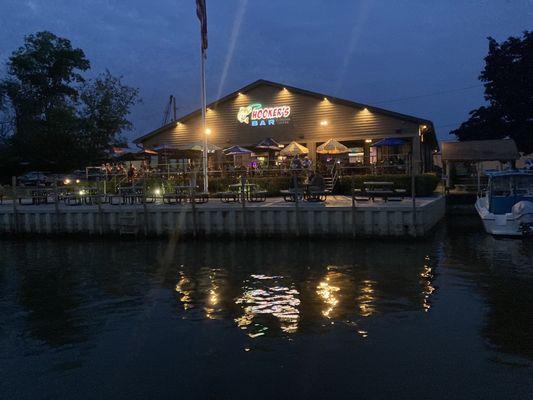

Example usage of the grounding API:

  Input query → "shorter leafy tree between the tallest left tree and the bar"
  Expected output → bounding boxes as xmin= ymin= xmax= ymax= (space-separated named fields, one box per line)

xmin=79 ymin=70 xmax=138 ymax=162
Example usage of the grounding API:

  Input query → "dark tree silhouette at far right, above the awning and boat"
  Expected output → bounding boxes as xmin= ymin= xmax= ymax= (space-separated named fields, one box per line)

xmin=450 ymin=31 xmax=533 ymax=153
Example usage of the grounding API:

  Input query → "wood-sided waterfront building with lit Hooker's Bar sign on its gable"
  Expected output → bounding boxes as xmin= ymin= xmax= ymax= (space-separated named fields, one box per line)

xmin=134 ymin=80 xmax=438 ymax=172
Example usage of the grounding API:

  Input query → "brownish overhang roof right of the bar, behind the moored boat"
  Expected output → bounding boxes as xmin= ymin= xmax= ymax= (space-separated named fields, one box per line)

xmin=441 ymin=139 xmax=520 ymax=161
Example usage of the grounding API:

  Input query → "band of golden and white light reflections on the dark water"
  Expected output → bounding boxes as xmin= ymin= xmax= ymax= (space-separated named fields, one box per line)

xmin=168 ymin=244 xmax=435 ymax=338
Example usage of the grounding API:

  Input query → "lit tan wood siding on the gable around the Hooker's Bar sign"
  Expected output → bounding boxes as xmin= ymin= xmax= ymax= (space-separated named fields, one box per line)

xmin=141 ymin=84 xmax=419 ymax=148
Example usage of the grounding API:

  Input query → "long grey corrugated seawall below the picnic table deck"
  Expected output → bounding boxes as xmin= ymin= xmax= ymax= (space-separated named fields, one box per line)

xmin=0 ymin=197 xmax=446 ymax=237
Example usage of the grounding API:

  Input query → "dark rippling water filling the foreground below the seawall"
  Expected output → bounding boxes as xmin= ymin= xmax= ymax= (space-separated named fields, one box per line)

xmin=0 ymin=219 xmax=533 ymax=399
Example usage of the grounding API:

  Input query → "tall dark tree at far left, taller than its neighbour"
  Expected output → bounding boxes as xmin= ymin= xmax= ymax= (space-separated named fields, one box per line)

xmin=1 ymin=32 xmax=90 ymax=169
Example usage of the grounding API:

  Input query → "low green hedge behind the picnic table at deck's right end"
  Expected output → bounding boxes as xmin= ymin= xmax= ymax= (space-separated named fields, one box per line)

xmin=335 ymin=174 xmax=439 ymax=196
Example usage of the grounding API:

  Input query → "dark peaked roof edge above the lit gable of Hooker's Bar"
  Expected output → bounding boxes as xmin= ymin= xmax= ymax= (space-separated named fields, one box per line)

xmin=133 ymin=79 xmax=434 ymax=144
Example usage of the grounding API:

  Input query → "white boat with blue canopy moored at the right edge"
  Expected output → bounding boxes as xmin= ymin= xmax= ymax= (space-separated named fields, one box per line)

xmin=476 ymin=170 xmax=533 ymax=236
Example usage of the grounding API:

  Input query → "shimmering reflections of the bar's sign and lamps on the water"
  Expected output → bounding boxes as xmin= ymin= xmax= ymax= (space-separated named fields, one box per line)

xmin=175 ymin=256 xmax=436 ymax=338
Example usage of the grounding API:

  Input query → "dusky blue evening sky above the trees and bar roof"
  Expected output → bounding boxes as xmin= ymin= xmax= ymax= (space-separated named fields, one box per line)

xmin=0 ymin=0 xmax=533 ymax=139
